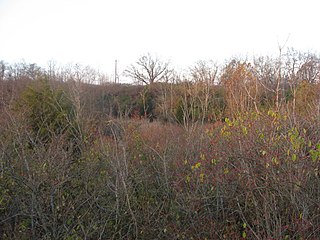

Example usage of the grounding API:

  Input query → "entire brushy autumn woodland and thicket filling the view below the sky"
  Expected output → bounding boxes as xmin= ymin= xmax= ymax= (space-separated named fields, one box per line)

xmin=0 ymin=49 xmax=320 ymax=240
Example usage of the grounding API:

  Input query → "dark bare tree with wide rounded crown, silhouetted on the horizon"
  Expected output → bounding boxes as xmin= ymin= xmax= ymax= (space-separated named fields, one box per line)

xmin=125 ymin=54 xmax=171 ymax=85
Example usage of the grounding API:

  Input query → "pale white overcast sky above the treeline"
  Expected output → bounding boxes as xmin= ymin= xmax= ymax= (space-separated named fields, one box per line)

xmin=0 ymin=0 xmax=320 ymax=79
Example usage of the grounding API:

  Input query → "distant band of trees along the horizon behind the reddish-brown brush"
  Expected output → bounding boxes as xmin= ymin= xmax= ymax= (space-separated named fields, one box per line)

xmin=0 ymin=49 xmax=320 ymax=124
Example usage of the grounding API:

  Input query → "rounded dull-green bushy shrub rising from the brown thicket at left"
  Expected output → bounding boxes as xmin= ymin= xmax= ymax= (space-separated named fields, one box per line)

xmin=18 ymin=79 xmax=79 ymax=147
